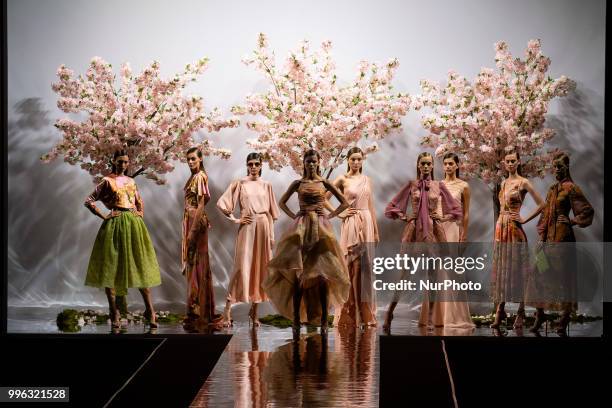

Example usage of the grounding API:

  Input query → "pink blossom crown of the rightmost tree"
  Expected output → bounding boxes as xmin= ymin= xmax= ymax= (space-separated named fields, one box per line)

xmin=412 ymin=40 xmax=576 ymax=186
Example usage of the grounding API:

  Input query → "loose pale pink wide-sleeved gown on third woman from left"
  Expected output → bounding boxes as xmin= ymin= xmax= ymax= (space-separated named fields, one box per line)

xmin=217 ymin=177 xmax=278 ymax=303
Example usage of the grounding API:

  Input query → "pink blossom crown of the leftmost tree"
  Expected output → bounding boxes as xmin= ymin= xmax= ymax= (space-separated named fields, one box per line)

xmin=41 ymin=57 xmax=240 ymax=184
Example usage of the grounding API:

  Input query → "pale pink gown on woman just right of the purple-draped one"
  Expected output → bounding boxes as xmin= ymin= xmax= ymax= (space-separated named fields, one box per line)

xmin=433 ymin=179 xmax=475 ymax=329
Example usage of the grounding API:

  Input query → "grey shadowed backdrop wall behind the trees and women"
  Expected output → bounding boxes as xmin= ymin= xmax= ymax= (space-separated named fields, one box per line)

xmin=7 ymin=0 xmax=606 ymax=313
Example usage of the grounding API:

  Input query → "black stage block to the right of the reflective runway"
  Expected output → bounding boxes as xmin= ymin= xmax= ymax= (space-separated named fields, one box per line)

xmin=379 ymin=336 xmax=610 ymax=408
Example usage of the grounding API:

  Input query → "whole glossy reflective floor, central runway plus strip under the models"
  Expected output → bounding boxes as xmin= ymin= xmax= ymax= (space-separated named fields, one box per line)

xmin=8 ymin=304 xmax=603 ymax=407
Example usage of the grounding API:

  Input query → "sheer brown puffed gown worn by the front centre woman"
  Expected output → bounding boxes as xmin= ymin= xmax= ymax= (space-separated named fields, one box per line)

xmin=264 ymin=180 xmax=351 ymax=324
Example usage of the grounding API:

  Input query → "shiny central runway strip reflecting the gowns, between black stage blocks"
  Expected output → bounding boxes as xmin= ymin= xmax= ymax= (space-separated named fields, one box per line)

xmin=191 ymin=327 xmax=378 ymax=407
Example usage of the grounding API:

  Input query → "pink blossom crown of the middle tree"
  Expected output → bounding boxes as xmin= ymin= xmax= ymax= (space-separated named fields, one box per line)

xmin=232 ymin=34 xmax=411 ymax=175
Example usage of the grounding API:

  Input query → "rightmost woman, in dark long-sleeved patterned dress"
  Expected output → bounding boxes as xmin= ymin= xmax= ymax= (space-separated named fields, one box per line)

xmin=530 ymin=153 xmax=595 ymax=336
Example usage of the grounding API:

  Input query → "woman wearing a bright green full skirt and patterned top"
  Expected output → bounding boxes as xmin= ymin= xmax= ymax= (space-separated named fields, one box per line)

xmin=85 ymin=150 xmax=161 ymax=332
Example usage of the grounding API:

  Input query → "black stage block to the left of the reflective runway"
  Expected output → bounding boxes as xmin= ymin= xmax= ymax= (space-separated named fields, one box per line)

xmin=0 ymin=334 xmax=232 ymax=407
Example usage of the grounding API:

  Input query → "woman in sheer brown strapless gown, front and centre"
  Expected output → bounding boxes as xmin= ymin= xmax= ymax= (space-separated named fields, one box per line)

xmin=264 ymin=150 xmax=350 ymax=337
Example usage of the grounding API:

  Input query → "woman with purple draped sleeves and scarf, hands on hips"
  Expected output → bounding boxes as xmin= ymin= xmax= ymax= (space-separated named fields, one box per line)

xmin=383 ymin=152 xmax=462 ymax=333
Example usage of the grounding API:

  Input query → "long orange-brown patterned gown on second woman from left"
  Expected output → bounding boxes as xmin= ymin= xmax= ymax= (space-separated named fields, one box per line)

xmin=182 ymin=170 xmax=221 ymax=324
